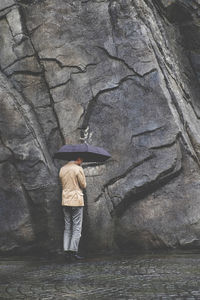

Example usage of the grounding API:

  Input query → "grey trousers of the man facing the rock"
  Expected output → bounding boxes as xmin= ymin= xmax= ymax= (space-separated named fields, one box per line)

xmin=63 ymin=206 xmax=83 ymax=252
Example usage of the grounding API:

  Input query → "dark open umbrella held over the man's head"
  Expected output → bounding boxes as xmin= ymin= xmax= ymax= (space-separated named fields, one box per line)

xmin=54 ymin=143 xmax=111 ymax=162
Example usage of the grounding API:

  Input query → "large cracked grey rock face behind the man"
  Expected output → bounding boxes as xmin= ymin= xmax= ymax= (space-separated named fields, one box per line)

xmin=0 ymin=0 xmax=200 ymax=252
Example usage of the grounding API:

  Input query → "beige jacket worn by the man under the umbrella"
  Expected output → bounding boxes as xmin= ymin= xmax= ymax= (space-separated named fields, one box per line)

xmin=59 ymin=161 xmax=86 ymax=206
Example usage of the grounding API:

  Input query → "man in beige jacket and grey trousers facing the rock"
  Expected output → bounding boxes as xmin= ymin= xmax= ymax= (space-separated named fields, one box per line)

xmin=59 ymin=157 xmax=86 ymax=259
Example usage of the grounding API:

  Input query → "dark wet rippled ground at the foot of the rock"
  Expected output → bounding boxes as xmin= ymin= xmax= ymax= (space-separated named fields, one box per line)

xmin=0 ymin=253 xmax=200 ymax=300
